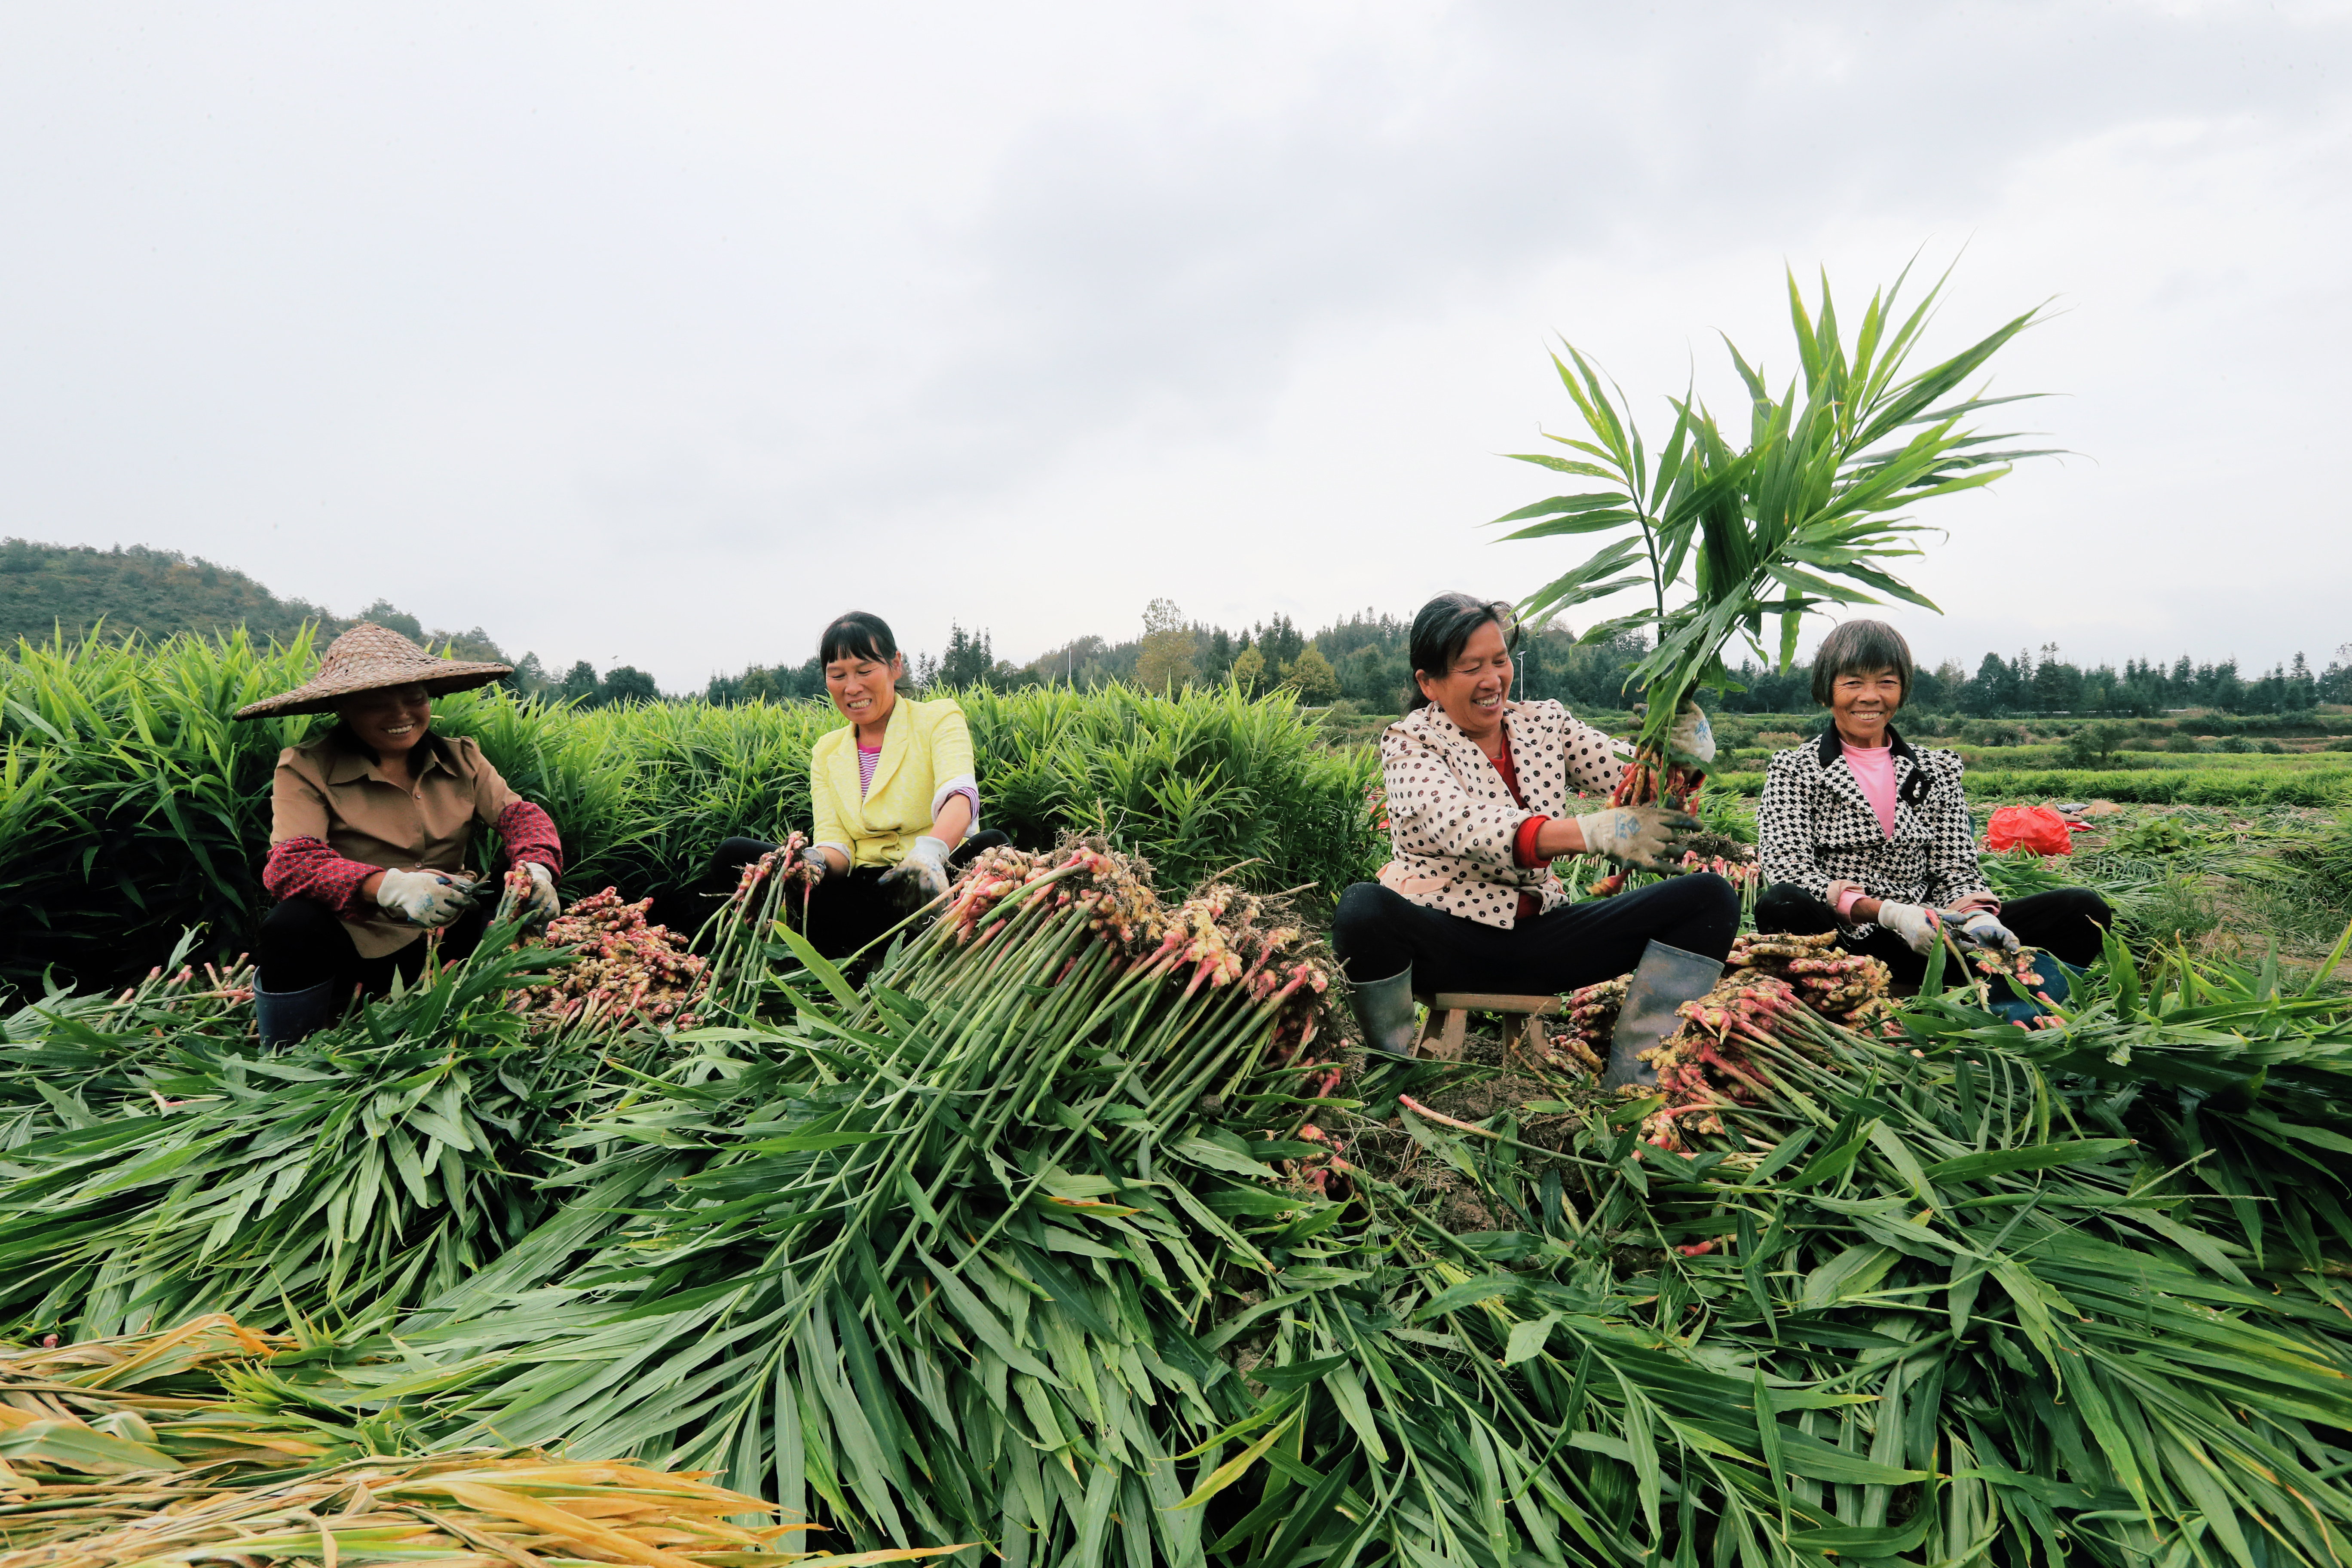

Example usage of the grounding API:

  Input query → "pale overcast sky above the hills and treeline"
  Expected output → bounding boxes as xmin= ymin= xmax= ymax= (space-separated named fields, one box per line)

xmin=0 ymin=0 xmax=2352 ymax=689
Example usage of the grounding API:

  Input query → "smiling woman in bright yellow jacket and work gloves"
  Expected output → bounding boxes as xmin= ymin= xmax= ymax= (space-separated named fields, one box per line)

xmin=656 ymin=611 xmax=1011 ymax=959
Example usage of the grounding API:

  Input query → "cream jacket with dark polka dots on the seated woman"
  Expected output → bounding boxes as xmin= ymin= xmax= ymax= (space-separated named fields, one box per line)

xmin=1381 ymin=701 xmax=1632 ymax=931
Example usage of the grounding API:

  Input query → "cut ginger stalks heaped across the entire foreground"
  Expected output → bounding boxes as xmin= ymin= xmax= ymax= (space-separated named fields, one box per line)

xmin=14 ymin=844 xmax=2352 ymax=1568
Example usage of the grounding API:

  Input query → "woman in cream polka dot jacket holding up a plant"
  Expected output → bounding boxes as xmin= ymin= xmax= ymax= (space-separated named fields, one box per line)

xmin=1331 ymin=592 xmax=1740 ymax=1079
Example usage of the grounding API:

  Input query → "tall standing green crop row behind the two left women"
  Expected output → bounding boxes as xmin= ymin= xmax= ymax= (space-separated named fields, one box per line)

xmin=0 ymin=635 xmax=1385 ymax=990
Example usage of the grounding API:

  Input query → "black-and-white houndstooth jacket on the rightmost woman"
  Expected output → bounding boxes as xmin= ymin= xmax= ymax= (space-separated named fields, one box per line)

xmin=1757 ymin=724 xmax=1990 ymax=936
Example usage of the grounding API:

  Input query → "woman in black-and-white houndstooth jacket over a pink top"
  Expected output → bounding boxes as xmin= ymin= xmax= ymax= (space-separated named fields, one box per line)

xmin=1757 ymin=621 xmax=2114 ymax=980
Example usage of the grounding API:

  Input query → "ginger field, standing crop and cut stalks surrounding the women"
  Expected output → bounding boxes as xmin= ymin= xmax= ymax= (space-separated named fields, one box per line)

xmin=14 ymin=644 xmax=2352 ymax=1568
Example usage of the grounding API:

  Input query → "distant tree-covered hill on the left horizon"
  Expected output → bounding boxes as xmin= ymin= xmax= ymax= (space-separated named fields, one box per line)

xmin=0 ymin=538 xmax=513 ymax=663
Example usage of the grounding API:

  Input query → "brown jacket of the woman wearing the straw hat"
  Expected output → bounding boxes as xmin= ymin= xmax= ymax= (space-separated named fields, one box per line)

xmin=270 ymin=729 xmax=518 ymax=959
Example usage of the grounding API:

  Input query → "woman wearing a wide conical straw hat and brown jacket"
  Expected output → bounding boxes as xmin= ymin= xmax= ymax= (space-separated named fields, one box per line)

xmin=238 ymin=621 xmax=564 ymax=1041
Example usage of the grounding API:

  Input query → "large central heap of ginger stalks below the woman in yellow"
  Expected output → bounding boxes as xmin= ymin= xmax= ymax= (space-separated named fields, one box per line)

xmin=308 ymin=842 xmax=1336 ymax=1561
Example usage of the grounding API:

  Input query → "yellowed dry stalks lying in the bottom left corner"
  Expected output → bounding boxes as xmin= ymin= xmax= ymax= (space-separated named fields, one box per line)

xmin=0 ymin=1314 xmax=952 ymax=1568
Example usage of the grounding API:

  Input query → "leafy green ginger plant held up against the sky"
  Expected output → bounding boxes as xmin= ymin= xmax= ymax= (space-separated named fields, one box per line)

xmin=1496 ymin=268 xmax=2044 ymax=841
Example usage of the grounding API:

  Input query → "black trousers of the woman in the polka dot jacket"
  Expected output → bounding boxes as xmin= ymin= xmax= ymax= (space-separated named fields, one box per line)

xmin=1331 ymin=872 xmax=1740 ymax=997
